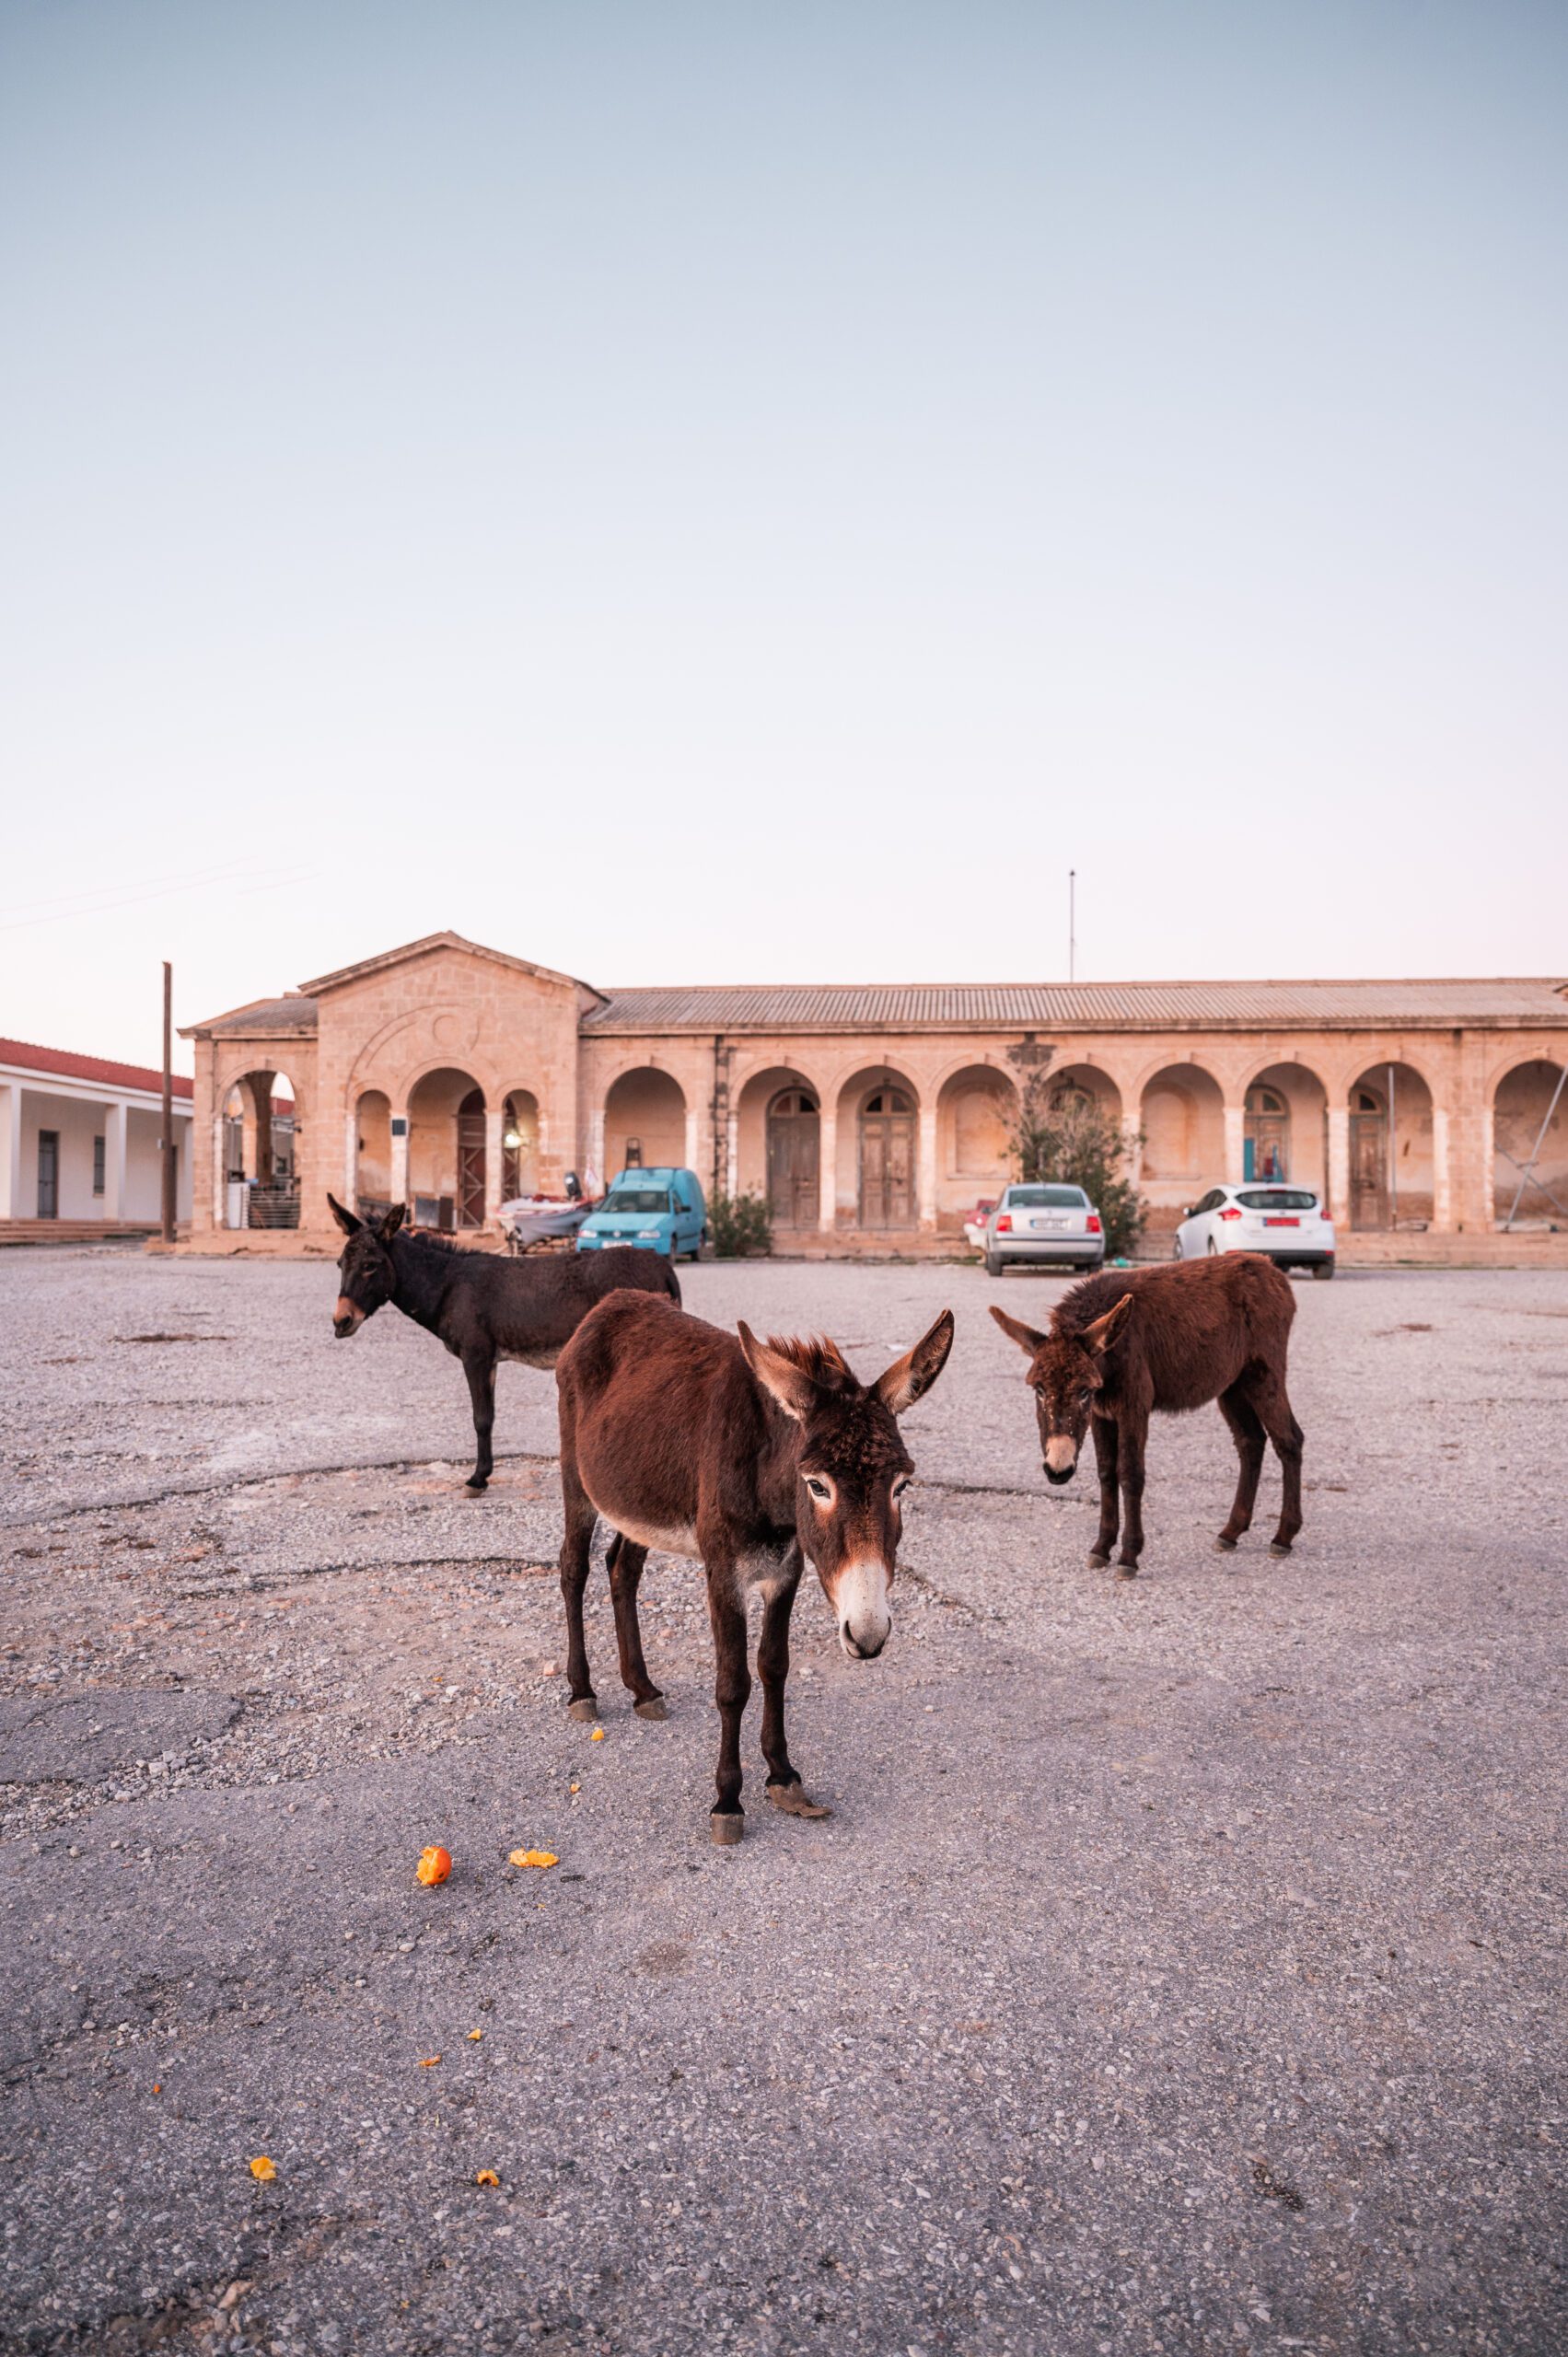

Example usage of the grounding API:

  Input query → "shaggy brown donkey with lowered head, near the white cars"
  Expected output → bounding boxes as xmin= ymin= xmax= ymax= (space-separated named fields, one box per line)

xmin=991 ymin=1251 xmax=1302 ymax=1579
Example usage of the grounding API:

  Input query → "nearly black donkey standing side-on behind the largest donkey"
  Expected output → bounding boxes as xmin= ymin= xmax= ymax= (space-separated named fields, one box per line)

xmin=328 ymin=1195 xmax=681 ymax=1490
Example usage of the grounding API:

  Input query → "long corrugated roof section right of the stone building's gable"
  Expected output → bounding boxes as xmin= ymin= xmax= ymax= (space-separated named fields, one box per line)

xmin=583 ymin=978 xmax=1568 ymax=1032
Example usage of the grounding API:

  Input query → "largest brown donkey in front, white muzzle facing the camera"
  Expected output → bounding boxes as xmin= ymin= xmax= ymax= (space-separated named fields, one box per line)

xmin=556 ymin=1294 xmax=953 ymax=1843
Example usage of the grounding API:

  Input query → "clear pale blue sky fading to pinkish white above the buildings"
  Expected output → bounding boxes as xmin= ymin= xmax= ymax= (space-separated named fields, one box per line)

xmin=0 ymin=0 xmax=1568 ymax=1058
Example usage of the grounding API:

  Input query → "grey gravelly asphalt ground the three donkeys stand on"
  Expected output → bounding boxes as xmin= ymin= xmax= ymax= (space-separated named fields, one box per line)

xmin=0 ymin=1249 xmax=1568 ymax=2357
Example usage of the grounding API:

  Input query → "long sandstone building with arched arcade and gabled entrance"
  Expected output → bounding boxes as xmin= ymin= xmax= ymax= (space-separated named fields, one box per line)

xmin=186 ymin=934 xmax=1568 ymax=1251
